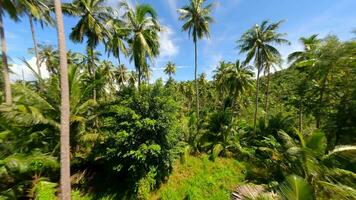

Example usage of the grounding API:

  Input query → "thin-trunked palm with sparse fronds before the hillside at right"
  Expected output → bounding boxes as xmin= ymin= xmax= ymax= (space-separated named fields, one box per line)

xmin=288 ymin=34 xmax=320 ymax=132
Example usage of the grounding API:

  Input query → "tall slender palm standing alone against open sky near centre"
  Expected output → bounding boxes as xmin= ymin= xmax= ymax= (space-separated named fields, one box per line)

xmin=178 ymin=0 xmax=213 ymax=131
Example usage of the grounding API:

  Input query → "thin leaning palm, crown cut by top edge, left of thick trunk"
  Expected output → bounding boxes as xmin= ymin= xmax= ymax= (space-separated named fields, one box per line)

xmin=19 ymin=0 xmax=53 ymax=79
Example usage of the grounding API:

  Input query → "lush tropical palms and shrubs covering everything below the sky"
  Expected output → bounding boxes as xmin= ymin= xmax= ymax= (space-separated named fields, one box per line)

xmin=0 ymin=0 xmax=356 ymax=200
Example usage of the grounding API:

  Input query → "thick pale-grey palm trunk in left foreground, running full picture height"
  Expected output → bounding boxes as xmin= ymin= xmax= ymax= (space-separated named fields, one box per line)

xmin=54 ymin=0 xmax=71 ymax=200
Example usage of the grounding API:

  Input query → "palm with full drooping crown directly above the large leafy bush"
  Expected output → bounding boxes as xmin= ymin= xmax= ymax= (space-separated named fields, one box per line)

xmin=120 ymin=2 xmax=161 ymax=86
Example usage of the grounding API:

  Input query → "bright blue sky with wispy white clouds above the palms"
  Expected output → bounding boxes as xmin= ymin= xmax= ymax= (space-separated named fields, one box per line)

xmin=5 ymin=0 xmax=356 ymax=80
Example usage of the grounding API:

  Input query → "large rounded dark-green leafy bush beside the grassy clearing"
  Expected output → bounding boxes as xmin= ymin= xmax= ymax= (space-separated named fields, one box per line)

xmin=93 ymin=81 xmax=180 ymax=195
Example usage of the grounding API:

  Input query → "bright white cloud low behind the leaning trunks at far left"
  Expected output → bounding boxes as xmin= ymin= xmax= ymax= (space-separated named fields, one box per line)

xmin=10 ymin=57 xmax=49 ymax=81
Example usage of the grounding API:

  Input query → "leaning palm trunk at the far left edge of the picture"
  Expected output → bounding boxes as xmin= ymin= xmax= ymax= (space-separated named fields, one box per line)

xmin=0 ymin=8 xmax=12 ymax=105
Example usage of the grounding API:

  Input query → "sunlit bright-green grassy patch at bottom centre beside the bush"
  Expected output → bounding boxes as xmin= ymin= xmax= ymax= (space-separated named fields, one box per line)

xmin=151 ymin=155 xmax=244 ymax=200
